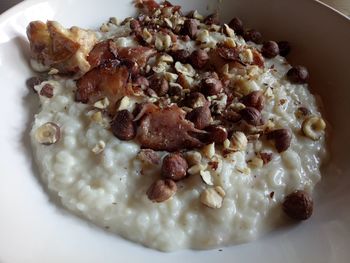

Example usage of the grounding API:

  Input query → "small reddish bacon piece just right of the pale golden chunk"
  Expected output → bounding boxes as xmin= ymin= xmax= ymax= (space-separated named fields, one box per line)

xmin=87 ymin=39 xmax=115 ymax=69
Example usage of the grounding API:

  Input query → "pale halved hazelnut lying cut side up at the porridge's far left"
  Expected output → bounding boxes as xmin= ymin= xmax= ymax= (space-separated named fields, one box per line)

xmin=35 ymin=122 xmax=61 ymax=145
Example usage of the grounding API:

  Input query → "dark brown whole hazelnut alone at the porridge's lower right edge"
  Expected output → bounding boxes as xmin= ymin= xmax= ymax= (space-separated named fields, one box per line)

xmin=282 ymin=190 xmax=313 ymax=220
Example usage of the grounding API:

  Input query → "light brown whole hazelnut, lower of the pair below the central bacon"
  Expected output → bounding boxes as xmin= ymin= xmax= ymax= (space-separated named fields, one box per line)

xmin=147 ymin=179 xmax=177 ymax=203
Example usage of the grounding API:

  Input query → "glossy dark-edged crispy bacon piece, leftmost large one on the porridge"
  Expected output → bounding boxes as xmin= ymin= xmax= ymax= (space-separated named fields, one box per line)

xmin=75 ymin=61 xmax=130 ymax=106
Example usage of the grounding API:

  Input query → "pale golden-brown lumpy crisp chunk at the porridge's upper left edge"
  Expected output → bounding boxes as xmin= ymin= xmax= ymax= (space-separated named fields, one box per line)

xmin=27 ymin=21 xmax=96 ymax=75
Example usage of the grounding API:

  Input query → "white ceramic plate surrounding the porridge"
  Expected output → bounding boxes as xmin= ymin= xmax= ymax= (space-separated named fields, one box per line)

xmin=0 ymin=0 xmax=350 ymax=263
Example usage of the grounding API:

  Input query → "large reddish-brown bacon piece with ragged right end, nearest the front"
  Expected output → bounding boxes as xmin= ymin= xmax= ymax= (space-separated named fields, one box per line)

xmin=137 ymin=105 xmax=205 ymax=152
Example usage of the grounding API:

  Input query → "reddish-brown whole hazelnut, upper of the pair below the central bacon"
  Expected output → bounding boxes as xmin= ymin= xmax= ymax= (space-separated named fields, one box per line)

xmin=161 ymin=153 xmax=188 ymax=181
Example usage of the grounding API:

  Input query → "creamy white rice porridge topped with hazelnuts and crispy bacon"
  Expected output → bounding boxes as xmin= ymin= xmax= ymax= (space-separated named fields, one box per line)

xmin=28 ymin=1 xmax=326 ymax=251
